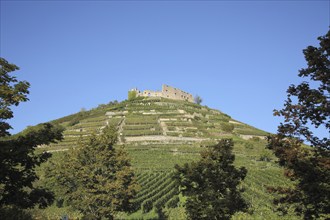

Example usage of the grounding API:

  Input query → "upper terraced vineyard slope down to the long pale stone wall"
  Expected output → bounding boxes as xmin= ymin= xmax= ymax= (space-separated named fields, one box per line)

xmin=41 ymin=98 xmax=267 ymax=150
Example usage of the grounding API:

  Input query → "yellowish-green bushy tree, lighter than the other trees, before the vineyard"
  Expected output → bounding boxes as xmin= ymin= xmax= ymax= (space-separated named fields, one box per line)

xmin=46 ymin=126 xmax=137 ymax=219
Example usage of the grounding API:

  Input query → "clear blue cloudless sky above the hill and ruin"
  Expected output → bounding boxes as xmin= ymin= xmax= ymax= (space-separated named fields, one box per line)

xmin=0 ymin=0 xmax=330 ymax=138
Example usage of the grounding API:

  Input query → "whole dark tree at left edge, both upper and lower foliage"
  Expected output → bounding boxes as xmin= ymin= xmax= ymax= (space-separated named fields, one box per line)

xmin=0 ymin=58 xmax=62 ymax=211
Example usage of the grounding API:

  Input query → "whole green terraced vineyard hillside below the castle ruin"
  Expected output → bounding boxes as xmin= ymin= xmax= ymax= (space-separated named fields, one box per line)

xmin=32 ymin=99 xmax=296 ymax=219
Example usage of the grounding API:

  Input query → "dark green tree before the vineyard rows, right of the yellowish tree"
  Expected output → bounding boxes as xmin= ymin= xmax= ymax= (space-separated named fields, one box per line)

xmin=175 ymin=139 xmax=247 ymax=219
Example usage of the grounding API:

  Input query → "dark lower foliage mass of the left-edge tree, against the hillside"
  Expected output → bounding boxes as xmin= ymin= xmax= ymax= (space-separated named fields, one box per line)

xmin=0 ymin=124 xmax=62 ymax=208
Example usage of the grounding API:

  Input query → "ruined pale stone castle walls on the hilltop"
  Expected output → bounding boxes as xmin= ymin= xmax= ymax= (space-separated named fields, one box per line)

xmin=130 ymin=85 xmax=194 ymax=102
